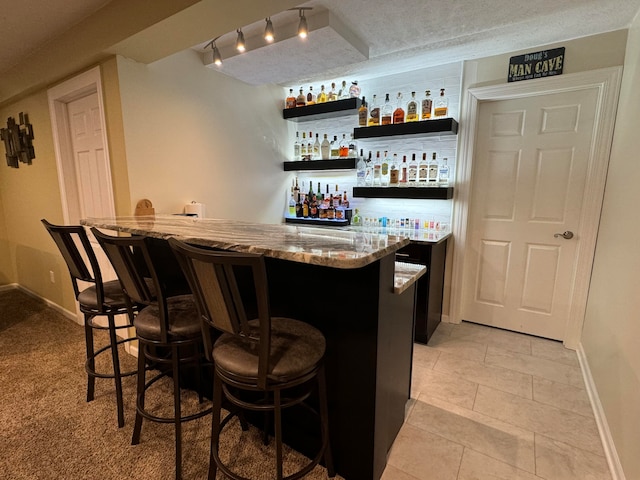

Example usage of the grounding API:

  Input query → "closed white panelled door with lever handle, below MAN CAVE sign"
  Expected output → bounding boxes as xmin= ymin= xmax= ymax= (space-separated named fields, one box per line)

xmin=461 ymin=88 xmax=599 ymax=340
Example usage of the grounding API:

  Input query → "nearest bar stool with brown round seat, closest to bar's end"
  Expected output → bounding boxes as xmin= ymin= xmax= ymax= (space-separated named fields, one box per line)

xmin=169 ymin=238 xmax=335 ymax=480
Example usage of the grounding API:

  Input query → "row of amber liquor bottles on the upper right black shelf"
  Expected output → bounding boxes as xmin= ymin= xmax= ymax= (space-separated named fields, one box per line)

xmin=358 ymin=88 xmax=449 ymax=127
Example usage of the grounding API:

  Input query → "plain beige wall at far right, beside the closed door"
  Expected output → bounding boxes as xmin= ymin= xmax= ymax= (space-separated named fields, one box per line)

xmin=582 ymin=8 xmax=640 ymax=480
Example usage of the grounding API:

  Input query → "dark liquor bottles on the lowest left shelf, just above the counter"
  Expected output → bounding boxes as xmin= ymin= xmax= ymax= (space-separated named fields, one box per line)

xmin=287 ymin=178 xmax=349 ymax=220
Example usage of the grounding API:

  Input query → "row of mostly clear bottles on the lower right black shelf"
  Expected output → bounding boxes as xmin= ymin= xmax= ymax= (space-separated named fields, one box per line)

xmin=356 ymin=149 xmax=450 ymax=187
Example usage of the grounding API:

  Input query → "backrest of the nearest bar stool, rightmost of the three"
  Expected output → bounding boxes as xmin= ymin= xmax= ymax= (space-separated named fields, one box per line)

xmin=169 ymin=238 xmax=271 ymax=388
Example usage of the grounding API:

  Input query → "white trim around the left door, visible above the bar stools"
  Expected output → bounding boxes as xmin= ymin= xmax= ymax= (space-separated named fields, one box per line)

xmin=47 ymin=66 xmax=116 ymax=224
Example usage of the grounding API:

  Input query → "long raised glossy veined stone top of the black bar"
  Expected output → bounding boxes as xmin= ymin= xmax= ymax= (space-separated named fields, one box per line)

xmin=80 ymin=215 xmax=409 ymax=269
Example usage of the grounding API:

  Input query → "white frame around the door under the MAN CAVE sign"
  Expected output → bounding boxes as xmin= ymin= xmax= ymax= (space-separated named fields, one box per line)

xmin=449 ymin=67 xmax=622 ymax=350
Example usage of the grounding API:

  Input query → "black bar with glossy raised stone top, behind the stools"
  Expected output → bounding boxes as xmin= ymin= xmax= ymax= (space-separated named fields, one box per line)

xmin=81 ymin=215 xmax=416 ymax=480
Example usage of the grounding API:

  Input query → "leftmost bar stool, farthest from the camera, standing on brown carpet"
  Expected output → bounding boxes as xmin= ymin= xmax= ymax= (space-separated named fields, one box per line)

xmin=41 ymin=218 xmax=138 ymax=427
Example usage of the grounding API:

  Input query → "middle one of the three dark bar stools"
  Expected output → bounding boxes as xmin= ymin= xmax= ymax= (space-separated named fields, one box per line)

xmin=91 ymin=228 xmax=211 ymax=480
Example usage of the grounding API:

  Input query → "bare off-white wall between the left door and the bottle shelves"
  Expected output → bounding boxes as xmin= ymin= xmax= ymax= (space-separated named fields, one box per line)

xmin=118 ymin=50 xmax=290 ymax=223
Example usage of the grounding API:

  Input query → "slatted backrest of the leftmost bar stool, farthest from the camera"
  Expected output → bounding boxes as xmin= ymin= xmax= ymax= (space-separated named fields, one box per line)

xmin=40 ymin=218 xmax=104 ymax=308
